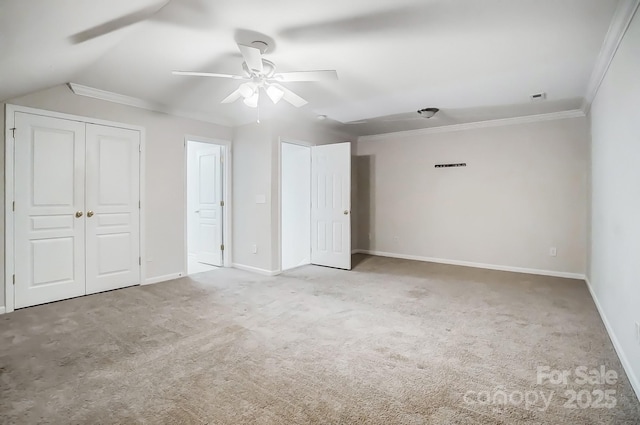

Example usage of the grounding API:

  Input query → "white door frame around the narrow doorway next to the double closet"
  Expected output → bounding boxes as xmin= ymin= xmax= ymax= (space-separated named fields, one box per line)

xmin=183 ymin=134 xmax=233 ymax=270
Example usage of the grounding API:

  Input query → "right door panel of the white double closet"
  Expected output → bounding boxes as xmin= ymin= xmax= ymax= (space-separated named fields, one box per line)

xmin=85 ymin=124 xmax=140 ymax=294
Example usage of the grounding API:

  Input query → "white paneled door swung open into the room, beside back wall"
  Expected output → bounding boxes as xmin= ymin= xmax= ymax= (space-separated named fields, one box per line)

xmin=311 ymin=143 xmax=351 ymax=270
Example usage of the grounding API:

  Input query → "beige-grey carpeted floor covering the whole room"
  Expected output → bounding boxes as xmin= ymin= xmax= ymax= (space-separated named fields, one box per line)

xmin=0 ymin=256 xmax=640 ymax=425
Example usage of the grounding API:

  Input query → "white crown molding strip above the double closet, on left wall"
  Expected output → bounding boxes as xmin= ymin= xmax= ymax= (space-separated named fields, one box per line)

xmin=67 ymin=83 xmax=233 ymax=127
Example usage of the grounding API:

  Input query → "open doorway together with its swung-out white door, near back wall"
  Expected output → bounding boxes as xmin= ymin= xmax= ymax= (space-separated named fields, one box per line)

xmin=280 ymin=141 xmax=351 ymax=271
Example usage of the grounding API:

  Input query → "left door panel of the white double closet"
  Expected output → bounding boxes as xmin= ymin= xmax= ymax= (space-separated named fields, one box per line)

xmin=14 ymin=112 xmax=85 ymax=308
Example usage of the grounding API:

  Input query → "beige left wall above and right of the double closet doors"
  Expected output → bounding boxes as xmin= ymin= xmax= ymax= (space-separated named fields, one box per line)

xmin=1 ymin=86 xmax=233 ymax=304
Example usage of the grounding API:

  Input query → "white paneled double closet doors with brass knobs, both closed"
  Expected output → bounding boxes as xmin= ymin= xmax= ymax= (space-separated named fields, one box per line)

xmin=14 ymin=112 xmax=140 ymax=308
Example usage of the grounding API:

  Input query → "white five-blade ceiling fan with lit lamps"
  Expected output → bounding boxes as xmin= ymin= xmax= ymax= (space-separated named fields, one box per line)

xmin=173 ymin=41 xmax=338 ymax=108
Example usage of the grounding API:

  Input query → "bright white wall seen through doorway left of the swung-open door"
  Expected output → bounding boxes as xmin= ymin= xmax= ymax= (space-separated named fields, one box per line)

xmin=281 ymin=143 xmax=311 ymax=270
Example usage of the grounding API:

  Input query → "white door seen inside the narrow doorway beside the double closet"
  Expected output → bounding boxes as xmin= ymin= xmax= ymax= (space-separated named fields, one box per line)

xmin=195 ymin=145 xmax=222 ymax=266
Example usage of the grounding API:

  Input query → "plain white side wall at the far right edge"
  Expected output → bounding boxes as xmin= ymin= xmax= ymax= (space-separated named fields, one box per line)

xmin=588 ymin=8 xmax=640 ymax=397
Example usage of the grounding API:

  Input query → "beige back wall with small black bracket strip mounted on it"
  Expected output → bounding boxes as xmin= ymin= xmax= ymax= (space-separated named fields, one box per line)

xmin=357 ymin=118 xmax=588 ymax=275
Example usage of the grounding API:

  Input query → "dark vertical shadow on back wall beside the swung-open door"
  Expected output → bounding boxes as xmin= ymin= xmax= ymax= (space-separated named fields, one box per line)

xmin=355 ymin=155 xmax=376 ymax=250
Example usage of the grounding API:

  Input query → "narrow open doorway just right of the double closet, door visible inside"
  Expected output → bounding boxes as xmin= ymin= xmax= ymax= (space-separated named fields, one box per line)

xmin=186 ymin=139 xmax=226 ymax=274
